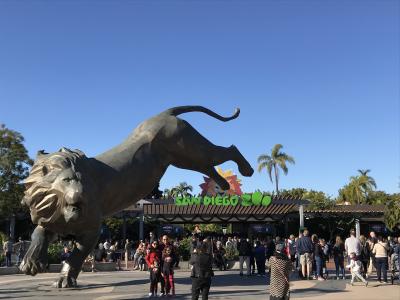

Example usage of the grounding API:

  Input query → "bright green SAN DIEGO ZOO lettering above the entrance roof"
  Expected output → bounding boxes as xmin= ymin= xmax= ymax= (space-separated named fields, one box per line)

xmin=175 ymin=192 xmax=272 ymax=206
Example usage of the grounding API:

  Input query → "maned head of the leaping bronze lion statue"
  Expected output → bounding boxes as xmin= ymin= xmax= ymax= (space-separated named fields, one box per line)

xmin=22 ymin=148 xmax=87 ymax=226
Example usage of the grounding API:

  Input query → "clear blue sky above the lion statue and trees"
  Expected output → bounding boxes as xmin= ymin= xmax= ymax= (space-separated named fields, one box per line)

xmin=0 ymin=0 xmax=400 ymax=196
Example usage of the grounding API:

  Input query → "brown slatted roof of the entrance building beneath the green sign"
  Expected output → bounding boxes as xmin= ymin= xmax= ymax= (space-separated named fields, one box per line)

xmin=119 ymin=197 xmax=385 ymax=223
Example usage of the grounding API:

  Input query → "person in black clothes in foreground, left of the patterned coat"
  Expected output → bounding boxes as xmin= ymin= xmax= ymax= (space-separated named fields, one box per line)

xmin=189 ymin=242 xmax=214 ymax=300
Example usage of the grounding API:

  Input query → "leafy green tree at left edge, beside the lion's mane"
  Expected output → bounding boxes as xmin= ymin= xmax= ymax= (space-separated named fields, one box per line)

xmin=0 ymin=124 xmax=33 ymax=218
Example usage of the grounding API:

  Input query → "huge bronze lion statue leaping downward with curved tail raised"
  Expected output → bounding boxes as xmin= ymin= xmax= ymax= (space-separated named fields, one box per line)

xmin=20 ymin=106 xmax=253 ymax=287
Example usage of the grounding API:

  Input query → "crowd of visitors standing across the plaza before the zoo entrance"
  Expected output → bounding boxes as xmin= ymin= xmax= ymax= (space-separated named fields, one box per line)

xmin=3 ymin=229 xmax=400 ymax=300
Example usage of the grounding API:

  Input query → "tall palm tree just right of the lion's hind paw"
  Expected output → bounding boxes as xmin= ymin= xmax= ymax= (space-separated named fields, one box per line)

xmin=257 ymin=144 xmax=295 ymax=195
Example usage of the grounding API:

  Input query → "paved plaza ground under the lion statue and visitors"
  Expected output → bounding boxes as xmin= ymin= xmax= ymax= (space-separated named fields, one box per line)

xmin=0 ymin=271 xmax=400 ymax=300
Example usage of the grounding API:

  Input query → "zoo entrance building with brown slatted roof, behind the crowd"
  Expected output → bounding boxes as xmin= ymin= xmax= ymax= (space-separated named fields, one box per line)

xmin=119 ymin=197 xmax=385 ymax=239
